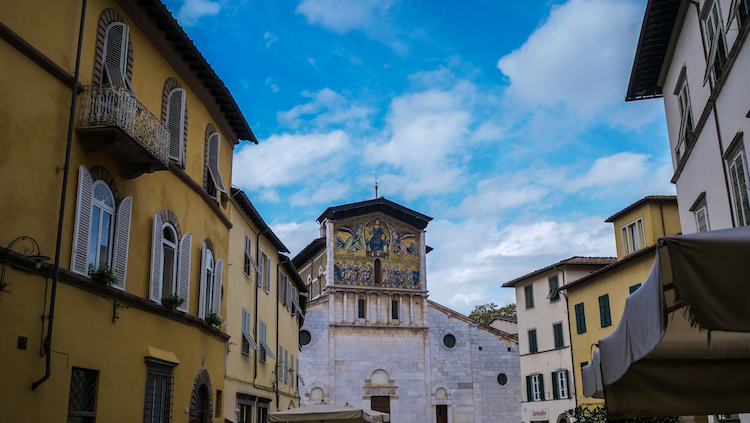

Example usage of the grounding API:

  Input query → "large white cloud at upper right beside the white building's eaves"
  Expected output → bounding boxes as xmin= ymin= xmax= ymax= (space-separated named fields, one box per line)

xmin=497 ymin=0 xmax=655 ymax=124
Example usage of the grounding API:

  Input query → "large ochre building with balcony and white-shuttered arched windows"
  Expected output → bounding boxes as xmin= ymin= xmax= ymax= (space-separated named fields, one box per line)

xmin=0 ymin=0 xmax=255 ymax=422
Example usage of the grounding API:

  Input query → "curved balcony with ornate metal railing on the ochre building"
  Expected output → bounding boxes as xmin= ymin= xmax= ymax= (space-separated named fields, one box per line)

xmin=76 ymin=84 xmax=169 ymax=179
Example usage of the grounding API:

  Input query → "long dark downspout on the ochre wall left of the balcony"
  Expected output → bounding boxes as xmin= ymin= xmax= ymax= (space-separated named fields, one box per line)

xmin=31 ymin=0 xmax=86 ymax=390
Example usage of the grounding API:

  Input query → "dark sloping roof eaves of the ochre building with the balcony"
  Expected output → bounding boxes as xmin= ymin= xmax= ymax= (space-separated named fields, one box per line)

xmin=133 ymin=0 xmax=258 ymax=144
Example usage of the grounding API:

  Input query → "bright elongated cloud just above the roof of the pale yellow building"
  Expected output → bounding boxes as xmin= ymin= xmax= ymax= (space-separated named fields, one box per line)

xmin=232 ymin=130 xmax=350 ymax=191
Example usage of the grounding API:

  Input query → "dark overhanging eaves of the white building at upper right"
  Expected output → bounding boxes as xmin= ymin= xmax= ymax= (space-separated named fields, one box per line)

xmin=625 ymin=0 xmax=681 ymax=101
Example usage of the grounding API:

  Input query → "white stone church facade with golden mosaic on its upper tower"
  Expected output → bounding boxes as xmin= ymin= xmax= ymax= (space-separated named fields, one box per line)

xmin=293 ymin=197 xmax=521 ymax=423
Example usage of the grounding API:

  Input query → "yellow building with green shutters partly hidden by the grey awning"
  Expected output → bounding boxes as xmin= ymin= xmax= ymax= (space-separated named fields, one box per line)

xmin=560 ymin=196 xmax=680 ymax=406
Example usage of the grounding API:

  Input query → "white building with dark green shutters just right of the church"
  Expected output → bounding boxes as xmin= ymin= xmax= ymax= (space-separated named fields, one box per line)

xmin=503 ymin=257 xmax=616 ymax=423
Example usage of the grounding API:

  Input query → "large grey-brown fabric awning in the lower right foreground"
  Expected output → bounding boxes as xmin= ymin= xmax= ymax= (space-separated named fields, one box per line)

xmin=583 ymin=227 xmax=750 ymax=419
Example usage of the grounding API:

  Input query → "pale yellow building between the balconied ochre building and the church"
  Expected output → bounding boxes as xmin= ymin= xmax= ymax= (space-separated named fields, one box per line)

xmin=224 ymin=188 xmax=307 ymax=423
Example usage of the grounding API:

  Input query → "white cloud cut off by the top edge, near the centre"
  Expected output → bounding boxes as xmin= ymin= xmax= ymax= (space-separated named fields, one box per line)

xmin=296 ymin=0 xmax=395 ymax=34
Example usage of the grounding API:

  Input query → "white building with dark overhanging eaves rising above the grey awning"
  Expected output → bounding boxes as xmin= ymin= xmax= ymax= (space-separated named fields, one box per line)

xmin=626 ymin=0 xmax=750 ymax=422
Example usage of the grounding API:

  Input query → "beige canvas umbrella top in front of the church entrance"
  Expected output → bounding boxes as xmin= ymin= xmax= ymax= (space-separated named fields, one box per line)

xmin=268 ymin=404 xmax=391 ymax=423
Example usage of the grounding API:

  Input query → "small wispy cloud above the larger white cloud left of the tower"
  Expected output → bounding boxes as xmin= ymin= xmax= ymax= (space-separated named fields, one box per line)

xmin=277 ymin=88 xmax=371 ymax=129
